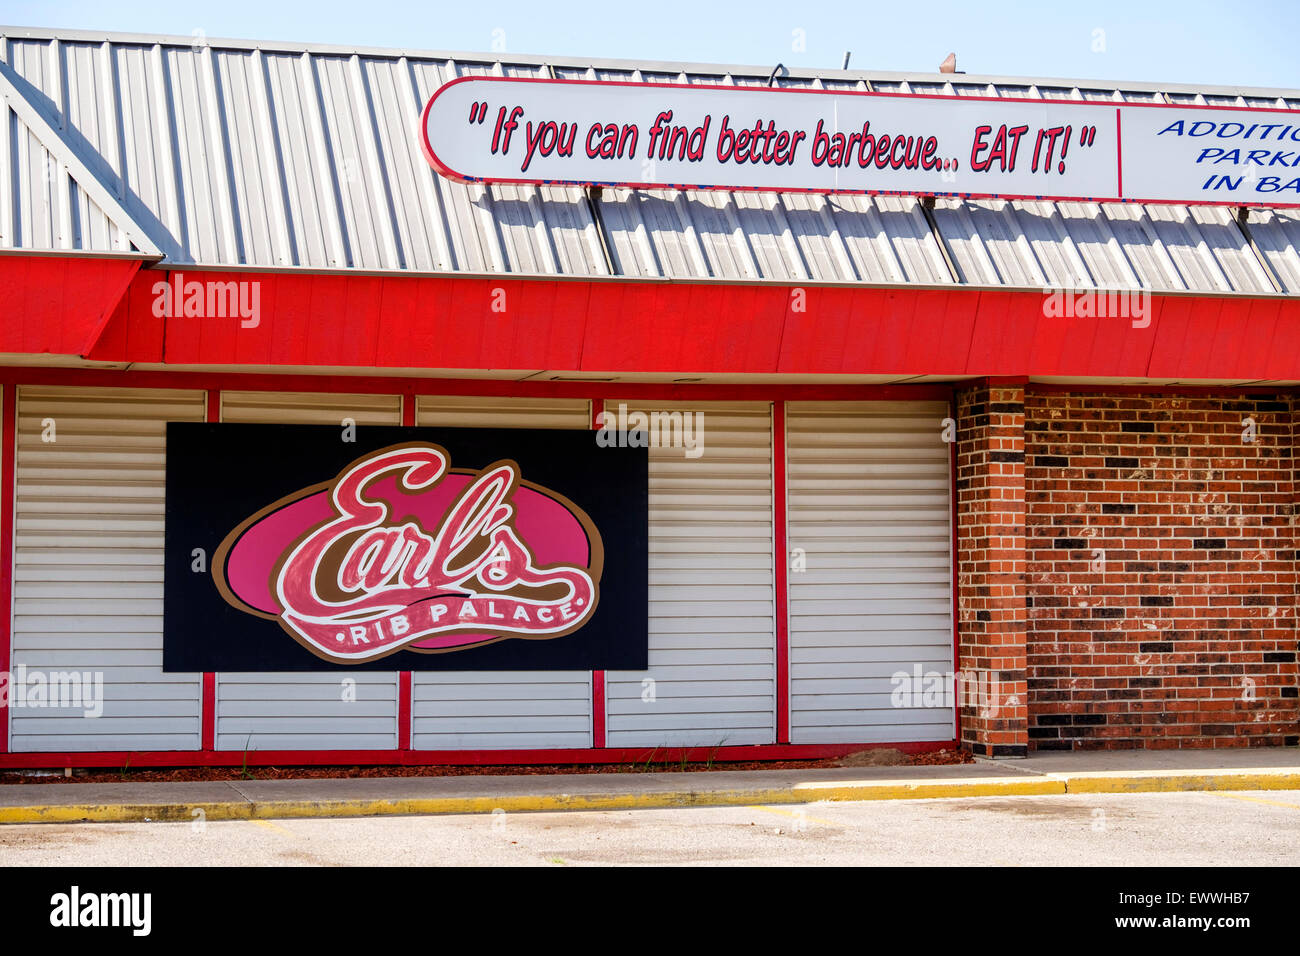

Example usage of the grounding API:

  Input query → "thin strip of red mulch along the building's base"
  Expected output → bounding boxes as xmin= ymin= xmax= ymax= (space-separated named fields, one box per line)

xmin=0 ymin=750 xmax=975 ymax=784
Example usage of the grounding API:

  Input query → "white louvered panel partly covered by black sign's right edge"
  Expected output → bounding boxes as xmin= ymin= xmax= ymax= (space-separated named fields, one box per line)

xmin=605 ymin=401 xmax=776 ymax=748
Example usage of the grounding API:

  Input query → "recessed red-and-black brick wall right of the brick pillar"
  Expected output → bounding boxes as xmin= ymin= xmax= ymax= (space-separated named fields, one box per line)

xmin=1024 ymin=389 xmax=1300 ymax=749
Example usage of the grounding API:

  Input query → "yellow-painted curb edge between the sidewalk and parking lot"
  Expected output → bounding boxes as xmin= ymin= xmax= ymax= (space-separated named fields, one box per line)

xmin=0 ymin=767 xmax=1300 ymax=823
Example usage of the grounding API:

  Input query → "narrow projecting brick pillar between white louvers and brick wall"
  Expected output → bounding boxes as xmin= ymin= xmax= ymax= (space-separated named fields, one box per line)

xmin=957 ymin=385 xmax=1028 ymax=757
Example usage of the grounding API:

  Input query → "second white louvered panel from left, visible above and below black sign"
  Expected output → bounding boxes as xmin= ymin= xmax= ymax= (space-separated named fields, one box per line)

xmin=217 ymin=392 xmax=402 ymax=750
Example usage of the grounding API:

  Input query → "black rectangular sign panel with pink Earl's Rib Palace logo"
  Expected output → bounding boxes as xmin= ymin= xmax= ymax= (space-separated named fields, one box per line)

xmin=163 ymin=421 xmax=649 ymax=672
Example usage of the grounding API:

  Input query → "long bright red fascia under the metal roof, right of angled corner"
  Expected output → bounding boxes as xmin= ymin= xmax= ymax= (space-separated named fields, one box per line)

xmin=50 ymin=269 xmax=1300 ymax=380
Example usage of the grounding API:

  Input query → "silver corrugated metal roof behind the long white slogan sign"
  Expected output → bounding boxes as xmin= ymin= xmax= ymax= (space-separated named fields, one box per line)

xmin=0 ymin=27 xmax=1300 ymax=293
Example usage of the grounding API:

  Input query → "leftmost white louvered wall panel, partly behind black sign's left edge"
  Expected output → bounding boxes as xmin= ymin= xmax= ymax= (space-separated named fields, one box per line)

xmin=7 ymin=386 xmax=204 ymax=752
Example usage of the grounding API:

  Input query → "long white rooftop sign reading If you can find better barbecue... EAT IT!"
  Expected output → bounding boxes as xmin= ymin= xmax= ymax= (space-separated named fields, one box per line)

xmin=421 ymin=77 xmax=1300 ymax=207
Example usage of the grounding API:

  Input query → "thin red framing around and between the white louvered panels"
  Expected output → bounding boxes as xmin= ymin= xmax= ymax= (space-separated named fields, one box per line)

xmin=0 ymin=367 xmax=954 ymax=769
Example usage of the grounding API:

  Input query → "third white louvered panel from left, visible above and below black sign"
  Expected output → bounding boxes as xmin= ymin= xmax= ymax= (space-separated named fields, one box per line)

xmin=411 ymin=395 xmax=592 ymax=750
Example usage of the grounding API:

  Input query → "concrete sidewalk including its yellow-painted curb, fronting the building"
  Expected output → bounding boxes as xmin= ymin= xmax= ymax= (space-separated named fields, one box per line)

xmin=0 ymin=748 xmax=1300 ymax=823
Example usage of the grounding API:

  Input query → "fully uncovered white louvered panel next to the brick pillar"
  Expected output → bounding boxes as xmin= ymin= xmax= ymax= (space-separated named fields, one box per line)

xmin=787 ymin=402 xmax=953 ymax=744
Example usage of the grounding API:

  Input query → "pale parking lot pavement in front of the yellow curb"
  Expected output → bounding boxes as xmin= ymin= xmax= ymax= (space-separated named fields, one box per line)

xmin=0 ymin=791 xmax=1300 ymax=866
